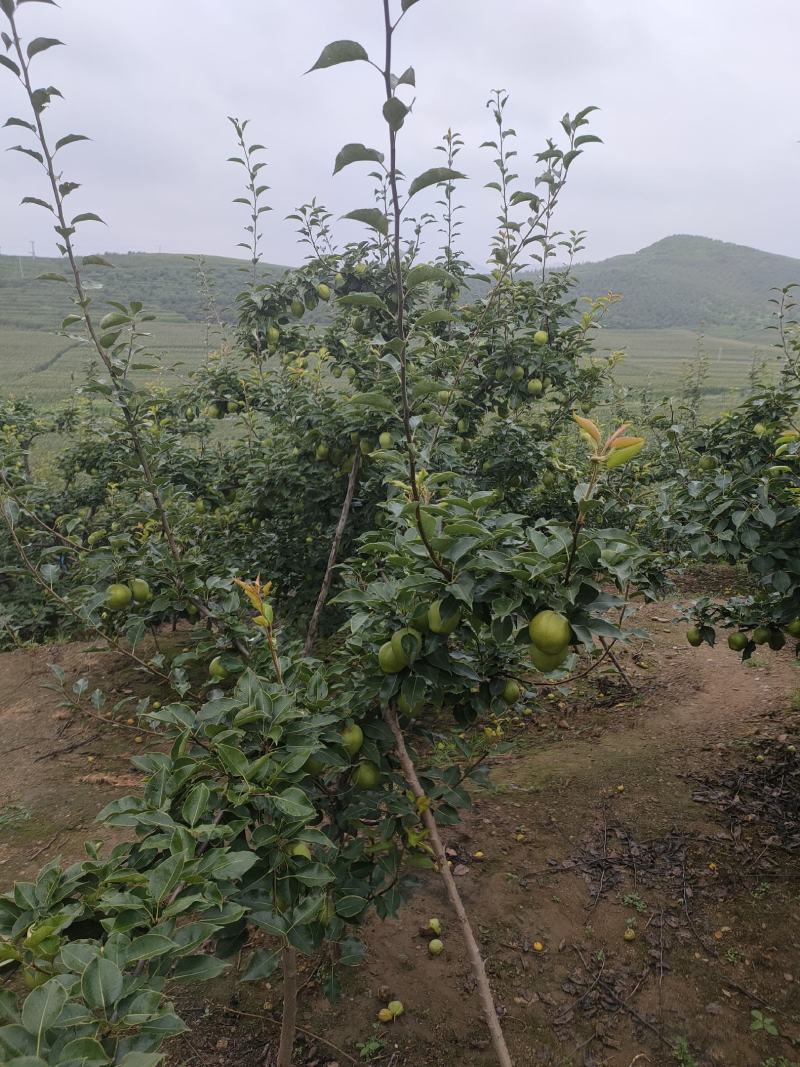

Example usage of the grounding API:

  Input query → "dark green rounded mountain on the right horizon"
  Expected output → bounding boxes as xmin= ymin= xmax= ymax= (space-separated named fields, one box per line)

xmin=575 ymin=234 xmax=800 ymax=332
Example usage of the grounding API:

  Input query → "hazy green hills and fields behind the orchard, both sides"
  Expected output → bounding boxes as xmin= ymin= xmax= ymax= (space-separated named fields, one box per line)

xmin=0 ymin=236 xmax=800 ymax=404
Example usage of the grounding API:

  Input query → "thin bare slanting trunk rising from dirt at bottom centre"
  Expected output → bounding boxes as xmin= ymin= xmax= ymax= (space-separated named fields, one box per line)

xmin=384 ymin=707 xmax=513 ymax=1067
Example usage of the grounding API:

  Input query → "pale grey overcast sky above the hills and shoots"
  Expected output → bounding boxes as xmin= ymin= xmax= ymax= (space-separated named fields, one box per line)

xmin=0 ymin=0 xmax=800 ymax=264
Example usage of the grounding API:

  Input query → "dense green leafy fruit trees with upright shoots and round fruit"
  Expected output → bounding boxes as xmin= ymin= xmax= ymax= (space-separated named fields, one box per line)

xmin=0 ymin=0 xmax=797 ymax=1067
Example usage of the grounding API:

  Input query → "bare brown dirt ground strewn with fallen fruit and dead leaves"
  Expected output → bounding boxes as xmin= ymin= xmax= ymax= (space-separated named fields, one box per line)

xmin=0 ymin=602 xmax=800 ymax=1067
